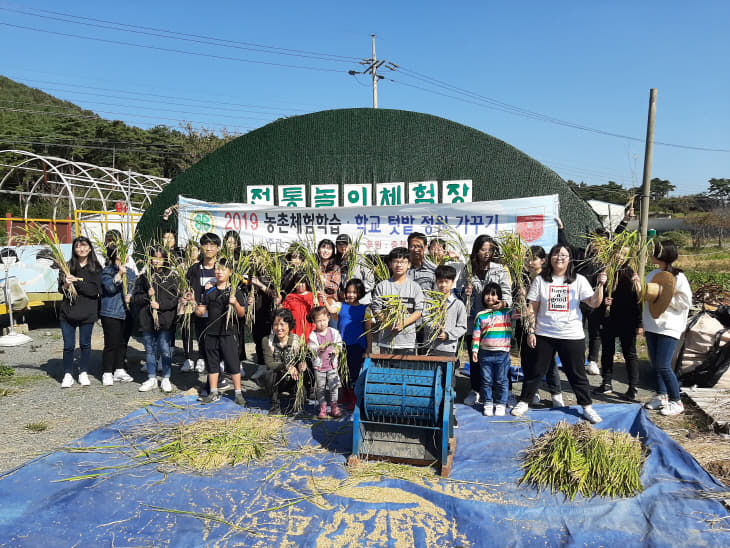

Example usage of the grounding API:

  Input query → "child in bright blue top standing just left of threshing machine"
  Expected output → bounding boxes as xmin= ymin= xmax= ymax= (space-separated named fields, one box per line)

xmin=324 ymin=278 xmax=370 ymax=410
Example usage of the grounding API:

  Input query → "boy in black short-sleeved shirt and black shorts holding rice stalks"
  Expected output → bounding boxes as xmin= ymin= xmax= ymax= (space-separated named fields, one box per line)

xmin=195 ymin=259 xmax=246 ymax=405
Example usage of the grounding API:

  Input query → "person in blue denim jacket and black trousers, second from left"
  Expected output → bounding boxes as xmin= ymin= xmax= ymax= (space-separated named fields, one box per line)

xmin=99 ymin=244 xmax=135 ymax=386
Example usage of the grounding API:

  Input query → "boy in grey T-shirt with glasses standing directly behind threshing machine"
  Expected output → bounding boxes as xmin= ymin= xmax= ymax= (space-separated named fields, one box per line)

xmin=368 ymin=247 xmax=423 ymax=355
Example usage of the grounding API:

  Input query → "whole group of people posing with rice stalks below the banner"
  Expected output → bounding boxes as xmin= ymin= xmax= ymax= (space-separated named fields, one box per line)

xmin=54 ymin=212 xmax=691 ymax=423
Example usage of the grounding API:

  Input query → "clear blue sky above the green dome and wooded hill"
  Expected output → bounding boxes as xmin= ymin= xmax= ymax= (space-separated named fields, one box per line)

xmin=0 ymin=0 xmax=730 ymax=195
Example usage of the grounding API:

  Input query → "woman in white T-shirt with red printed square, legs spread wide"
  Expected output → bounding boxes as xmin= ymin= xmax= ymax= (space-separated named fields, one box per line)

xmin=512 ymin=244 xmax=606 ymax=424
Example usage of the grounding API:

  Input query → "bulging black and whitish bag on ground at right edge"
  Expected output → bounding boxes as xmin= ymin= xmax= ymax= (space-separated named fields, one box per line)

xmin=672 ymin=311 xmax=730 ymax=388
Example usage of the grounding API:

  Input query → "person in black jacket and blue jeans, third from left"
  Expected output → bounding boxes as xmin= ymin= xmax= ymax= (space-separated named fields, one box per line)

xmin=134 ymin=246 xmax=179 ymax=392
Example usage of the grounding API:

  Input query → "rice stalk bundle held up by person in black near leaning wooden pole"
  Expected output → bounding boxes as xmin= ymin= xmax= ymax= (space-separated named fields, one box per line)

xmin=588 ymin=230 xmax=646 ymax=316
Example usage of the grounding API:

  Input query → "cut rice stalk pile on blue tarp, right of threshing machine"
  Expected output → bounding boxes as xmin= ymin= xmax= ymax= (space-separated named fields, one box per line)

xmin=520 ymin=421 xmax=646 ymax=500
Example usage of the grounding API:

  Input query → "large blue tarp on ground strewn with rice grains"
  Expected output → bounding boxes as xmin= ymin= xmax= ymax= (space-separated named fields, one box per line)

xmin=0 ymin=396 xmax=730 ymax=548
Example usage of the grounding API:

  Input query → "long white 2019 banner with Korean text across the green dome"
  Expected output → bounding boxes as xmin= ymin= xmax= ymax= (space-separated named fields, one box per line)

xmin=178 ymin=194 xmax=560 ymax=254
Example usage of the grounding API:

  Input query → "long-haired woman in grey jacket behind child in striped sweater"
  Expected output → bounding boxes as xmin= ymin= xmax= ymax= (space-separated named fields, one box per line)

xmin=455 ymin=234 xmax=512 ymax=405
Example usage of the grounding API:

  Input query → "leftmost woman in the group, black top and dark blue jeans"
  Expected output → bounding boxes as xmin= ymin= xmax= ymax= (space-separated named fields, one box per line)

xmin=58 ymin=236 xmax=101 ymax=388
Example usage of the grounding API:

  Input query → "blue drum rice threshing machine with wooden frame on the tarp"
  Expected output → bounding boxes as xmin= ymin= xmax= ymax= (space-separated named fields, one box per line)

xmin=348 ymin=354 xmax=456 ymax=477
